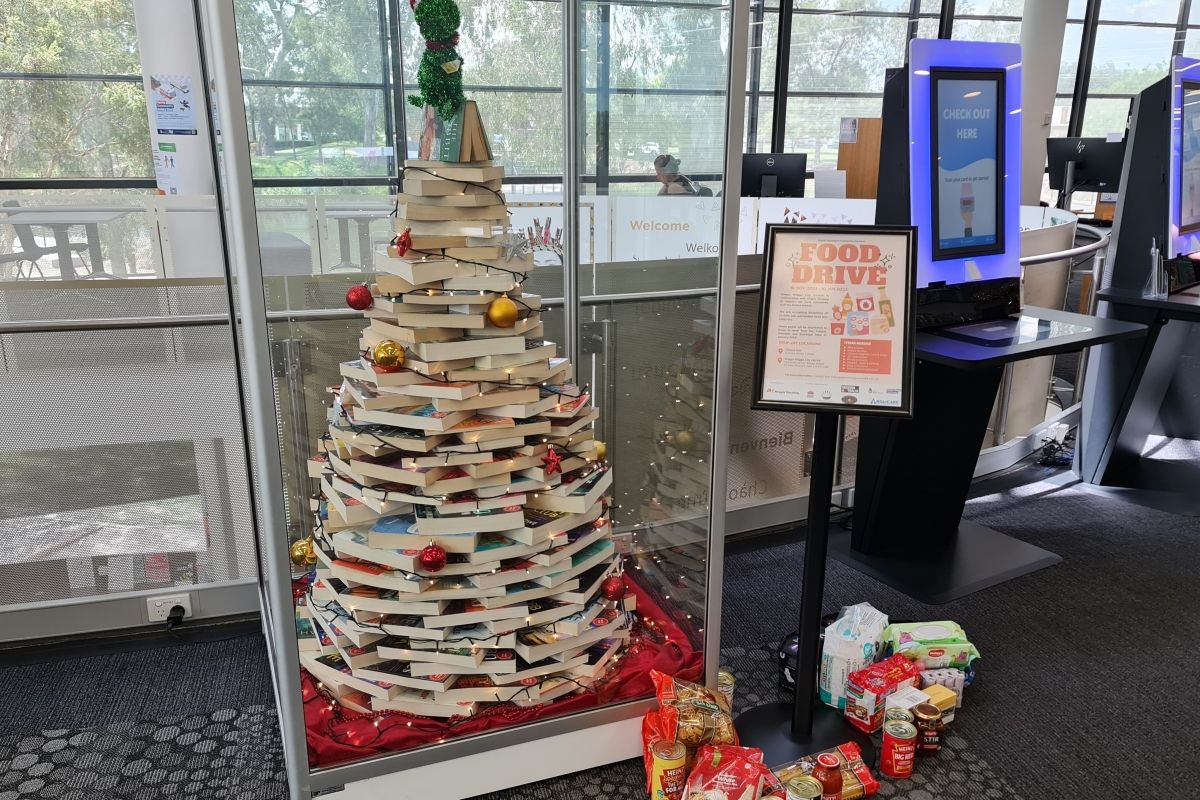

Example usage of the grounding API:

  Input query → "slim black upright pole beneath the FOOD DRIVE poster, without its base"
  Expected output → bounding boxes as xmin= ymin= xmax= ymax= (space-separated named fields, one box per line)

xmin=792 ymin=411 xmax=838 ymax=736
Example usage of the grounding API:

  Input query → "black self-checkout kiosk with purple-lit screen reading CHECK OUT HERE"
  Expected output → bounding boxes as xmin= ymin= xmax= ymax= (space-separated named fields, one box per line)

xmin=830 ymin=40 xmax=1139 ymax=603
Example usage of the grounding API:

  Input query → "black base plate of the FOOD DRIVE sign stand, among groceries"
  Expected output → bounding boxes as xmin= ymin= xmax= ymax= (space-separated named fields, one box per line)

xmin=734 ymin=700 xmax=875 ymax=768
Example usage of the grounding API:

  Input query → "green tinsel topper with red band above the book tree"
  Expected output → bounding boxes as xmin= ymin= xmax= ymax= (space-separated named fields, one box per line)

xmin=408 ymin=0 xmax=466 ymax=120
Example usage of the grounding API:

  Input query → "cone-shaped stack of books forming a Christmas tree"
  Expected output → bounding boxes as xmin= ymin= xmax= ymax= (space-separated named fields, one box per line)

xmin=298 ymin=155 xmax=634 ymax=718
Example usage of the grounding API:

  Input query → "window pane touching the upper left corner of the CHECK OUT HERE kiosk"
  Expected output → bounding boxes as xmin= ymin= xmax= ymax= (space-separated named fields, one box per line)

xmin=788 ymin=14 xmax=908 ymax=91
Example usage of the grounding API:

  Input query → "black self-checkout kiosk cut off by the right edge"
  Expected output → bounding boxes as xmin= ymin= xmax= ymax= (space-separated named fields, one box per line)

xmin=1076 ymin=56 xmax=1200 ymax=515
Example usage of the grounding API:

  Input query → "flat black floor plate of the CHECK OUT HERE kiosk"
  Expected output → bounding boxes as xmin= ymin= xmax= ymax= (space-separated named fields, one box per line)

xmin=829 ymin=521 xmax=1062 ymax=606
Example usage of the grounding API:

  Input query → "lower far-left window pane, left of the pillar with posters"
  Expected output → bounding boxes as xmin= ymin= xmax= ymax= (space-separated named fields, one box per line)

xmin=0 ymin=77 xmax=154 ymax=178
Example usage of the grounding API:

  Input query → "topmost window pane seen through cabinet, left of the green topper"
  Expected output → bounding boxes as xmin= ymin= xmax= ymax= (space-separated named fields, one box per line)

xmin=234 ymin=0 xmax=383 ymax=83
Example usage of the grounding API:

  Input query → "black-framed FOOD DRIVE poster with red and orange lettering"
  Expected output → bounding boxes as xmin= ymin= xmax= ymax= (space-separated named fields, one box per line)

xmin=752 ymin=224 xmax=917 ymax=417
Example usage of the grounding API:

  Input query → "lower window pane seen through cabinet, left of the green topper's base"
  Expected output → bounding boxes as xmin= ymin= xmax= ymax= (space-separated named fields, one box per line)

xmin=246 ymin=86 xmax=391 ymax=178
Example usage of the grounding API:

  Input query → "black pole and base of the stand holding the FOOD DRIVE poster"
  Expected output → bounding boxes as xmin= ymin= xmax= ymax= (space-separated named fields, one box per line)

xmin=736 ymin=411 xmax=875 ymax=766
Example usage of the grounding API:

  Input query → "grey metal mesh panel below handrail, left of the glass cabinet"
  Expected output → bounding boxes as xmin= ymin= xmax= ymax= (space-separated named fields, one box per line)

xmin=0 ymin=326 xmax=254 ymax=607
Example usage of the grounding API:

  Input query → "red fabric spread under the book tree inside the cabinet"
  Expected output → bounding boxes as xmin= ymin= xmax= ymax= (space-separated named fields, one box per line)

xmin=301 ymin=573 xmax=703 ymax=768
